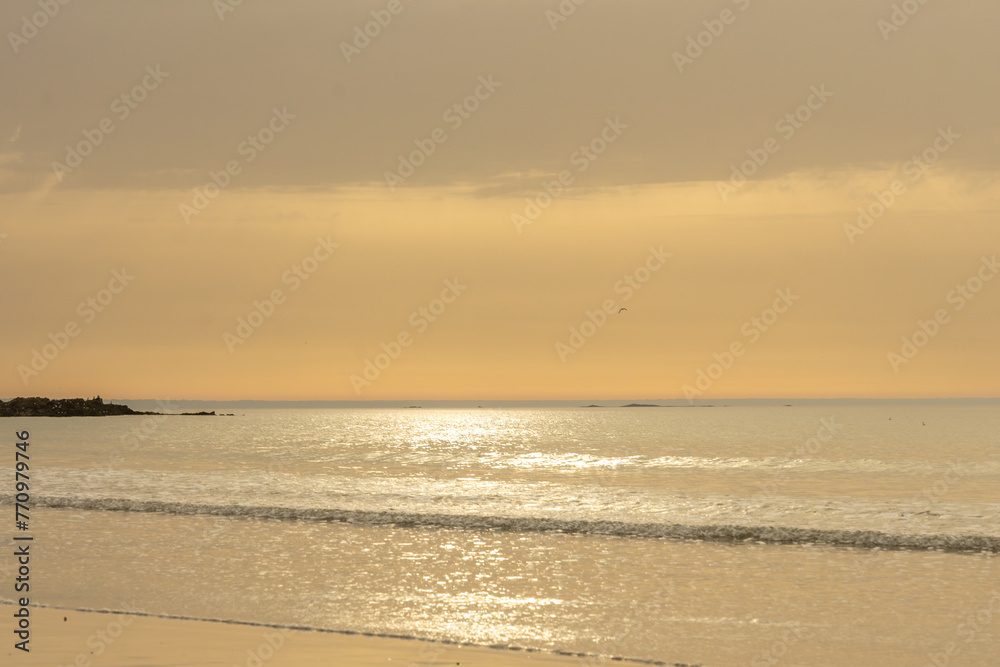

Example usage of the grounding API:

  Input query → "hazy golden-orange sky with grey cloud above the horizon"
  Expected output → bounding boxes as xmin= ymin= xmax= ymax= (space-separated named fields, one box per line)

xmin=0 ymin=0 xmax=1000 ymax=400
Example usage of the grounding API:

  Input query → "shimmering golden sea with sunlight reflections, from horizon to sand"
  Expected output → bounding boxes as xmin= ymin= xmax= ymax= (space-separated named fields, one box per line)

xmin=0 ymin=404 xmax=1000 ymax=667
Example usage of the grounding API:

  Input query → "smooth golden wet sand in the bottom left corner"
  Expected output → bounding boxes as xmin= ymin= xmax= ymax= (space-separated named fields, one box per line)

xmin=3 ymin=606 xmax=581 ymax=667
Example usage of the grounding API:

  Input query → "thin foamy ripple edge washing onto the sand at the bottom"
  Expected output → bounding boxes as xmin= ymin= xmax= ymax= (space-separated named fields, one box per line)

xmin=0 ymin=598 xmax=702 ymax=667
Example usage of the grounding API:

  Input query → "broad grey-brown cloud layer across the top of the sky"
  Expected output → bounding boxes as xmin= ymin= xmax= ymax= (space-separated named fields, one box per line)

xmin=0 ymin=0 xmax=1000 ymax=193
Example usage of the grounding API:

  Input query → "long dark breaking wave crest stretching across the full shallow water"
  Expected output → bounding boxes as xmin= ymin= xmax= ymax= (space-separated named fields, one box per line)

xmin=9 ymin=496 xmax=1000 ymax=553
